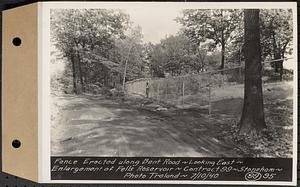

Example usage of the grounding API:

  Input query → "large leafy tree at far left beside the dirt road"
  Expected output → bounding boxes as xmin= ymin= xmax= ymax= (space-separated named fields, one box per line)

xmin=51 ymin=9 xmax=129 ymax=94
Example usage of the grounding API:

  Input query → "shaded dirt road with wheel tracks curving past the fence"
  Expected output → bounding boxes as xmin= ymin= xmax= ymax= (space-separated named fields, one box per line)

xmin=51 ymin=95 xmax=239 ymax=157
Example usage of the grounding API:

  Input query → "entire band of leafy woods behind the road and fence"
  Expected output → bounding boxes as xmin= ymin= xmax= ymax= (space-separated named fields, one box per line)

xmin=51 ymin=9 xmax=292 ymax=94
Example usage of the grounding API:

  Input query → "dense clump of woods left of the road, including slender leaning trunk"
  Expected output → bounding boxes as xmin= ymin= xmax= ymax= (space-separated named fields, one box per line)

xmin=51 ymin=9 xmax=144 ymax=94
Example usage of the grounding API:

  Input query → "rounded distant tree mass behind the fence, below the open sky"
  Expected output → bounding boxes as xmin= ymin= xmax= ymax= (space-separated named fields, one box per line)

xmin=147 ymin=33 xmax=207 ymax=77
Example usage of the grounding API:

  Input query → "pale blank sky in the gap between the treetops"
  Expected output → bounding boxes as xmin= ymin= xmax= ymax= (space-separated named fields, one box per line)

xmin=124 ymin=6 xmax=182 ymax=44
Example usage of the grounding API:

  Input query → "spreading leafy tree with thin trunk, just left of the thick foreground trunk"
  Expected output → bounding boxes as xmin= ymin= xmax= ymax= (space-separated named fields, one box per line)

xmin=177 ymin=9 xmax=241 ymax=69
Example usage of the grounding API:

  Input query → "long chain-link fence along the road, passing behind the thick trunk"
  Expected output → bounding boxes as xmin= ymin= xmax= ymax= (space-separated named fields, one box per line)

xmin=126 ymin=57 xmax=293 ymax=114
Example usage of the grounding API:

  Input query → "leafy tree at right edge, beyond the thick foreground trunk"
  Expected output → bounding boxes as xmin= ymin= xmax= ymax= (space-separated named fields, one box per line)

xmin=260 ymin=9 xmax=293 ymax=80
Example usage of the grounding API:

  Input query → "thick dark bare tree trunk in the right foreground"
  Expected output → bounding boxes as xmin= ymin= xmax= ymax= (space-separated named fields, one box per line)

xmin=239 ymin=9 xmax=266 ymax=136
